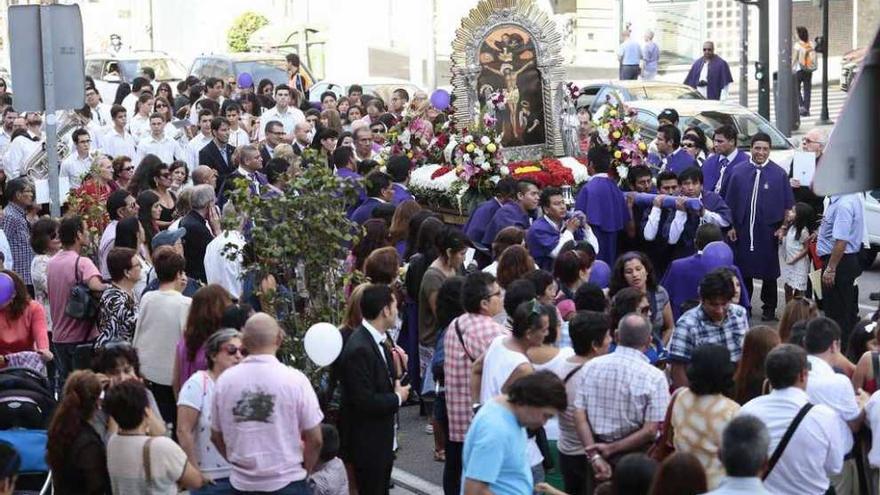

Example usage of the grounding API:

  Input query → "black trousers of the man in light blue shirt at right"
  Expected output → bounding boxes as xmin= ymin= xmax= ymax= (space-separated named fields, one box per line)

xmin=822 ymin=253 xmax=862 ymax=350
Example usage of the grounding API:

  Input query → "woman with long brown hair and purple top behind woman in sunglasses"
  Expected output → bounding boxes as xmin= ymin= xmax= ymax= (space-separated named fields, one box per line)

xmin=171 ymin=284 xmax=232 ymax=394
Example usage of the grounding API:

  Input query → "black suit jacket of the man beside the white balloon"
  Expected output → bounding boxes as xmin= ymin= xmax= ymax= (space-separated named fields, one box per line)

xmin=337 ymin=325 xmax=400 ymax=472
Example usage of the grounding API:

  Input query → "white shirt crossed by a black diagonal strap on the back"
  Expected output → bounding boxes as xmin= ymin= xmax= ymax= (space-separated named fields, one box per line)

xmin=739 ymin=388 xmax=847 ymax=495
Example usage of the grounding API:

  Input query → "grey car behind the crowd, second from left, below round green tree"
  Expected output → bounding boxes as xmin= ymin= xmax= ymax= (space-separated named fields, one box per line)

xmin=189 ymin=52 xmax=312 ymax=85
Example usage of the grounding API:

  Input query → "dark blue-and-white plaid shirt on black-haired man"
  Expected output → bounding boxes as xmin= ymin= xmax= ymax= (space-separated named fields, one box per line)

xmin=669 ymin=304 xmax=749 ymax=362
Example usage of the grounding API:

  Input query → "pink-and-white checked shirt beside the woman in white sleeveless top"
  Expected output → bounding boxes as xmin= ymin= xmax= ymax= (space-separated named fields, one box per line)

xmin=443 ymin=313 xmax=507 ymax=442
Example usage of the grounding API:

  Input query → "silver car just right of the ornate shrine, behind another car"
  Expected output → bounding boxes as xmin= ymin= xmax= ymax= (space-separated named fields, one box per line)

xmin=575 ymin=80 xmax=703 ymax=113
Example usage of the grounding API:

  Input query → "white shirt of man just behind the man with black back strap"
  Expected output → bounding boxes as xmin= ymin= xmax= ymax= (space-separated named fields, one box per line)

xmin=807 ymin=356 xmax=862 ymax=452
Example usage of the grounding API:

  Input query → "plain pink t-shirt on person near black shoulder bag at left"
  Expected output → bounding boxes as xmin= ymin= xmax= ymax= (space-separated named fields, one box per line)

xmin=46 ymin=250 xmax=101 ymax=344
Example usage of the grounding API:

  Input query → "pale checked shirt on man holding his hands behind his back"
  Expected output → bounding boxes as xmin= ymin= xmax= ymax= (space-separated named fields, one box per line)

xmin=574 ymin=346 xmax=669 ymax=442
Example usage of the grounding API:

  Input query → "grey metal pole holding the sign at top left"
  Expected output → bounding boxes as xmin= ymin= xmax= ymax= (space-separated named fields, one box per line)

xmin=40 ymin=5 xmax=61 ymax=217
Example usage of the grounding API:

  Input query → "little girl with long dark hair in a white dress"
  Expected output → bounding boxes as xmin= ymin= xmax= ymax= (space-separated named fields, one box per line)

xmin=779 ymin=203 xmax=816 ymax=302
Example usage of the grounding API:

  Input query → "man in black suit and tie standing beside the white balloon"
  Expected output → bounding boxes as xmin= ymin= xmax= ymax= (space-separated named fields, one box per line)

xmin=337 ymin=284 xmax=410 ymax=495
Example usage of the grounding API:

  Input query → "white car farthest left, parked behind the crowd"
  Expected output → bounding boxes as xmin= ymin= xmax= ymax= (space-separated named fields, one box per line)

xmin=85 ymin=50 xmax=186 ymax=103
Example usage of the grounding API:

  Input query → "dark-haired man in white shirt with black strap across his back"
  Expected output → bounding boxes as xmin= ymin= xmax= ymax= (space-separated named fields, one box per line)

xmin=739 ymin=344 xmax=846 ymax=495
